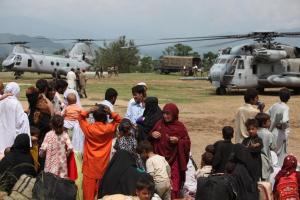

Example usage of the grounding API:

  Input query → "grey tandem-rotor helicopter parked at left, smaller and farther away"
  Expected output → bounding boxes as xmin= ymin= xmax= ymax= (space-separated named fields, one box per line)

xmin=0 ymin=38 xmax=95 ymax=79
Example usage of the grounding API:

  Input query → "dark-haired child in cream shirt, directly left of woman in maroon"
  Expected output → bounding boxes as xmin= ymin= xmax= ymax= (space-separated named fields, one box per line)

xmin=138 ymin=140 xmax=171 ymax=200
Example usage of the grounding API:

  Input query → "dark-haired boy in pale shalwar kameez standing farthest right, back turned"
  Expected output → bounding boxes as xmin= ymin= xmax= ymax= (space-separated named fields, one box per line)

xmin=267 ymin=88 xmax=291 ymax=166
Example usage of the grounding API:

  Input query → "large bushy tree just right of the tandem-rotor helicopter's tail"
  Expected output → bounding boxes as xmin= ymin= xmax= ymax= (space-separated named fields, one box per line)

xmin=96 ymin=36 xmax=139 ymax=72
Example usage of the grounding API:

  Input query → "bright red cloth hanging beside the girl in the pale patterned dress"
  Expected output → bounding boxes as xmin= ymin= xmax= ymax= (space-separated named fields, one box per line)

xmin=82 ymin=175 xmax=100 ymax=200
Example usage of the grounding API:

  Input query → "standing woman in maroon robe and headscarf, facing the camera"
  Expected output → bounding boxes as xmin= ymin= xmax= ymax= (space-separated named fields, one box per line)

xmin=149 ymin=103 xmax=191 ymax=199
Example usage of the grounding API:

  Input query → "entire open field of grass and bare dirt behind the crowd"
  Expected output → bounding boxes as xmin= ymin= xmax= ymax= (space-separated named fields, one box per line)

xmin=0 ymin=72 xmax=300 ymax=164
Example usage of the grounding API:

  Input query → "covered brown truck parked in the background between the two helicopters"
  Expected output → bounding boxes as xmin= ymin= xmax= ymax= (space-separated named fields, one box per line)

xmin=158 ymin=56 xmax=201 ymax=75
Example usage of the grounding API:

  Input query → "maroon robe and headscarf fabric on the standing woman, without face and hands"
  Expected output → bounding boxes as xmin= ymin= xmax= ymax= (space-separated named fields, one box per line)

xmin=150 ymin=103 xmax=191 ymax=194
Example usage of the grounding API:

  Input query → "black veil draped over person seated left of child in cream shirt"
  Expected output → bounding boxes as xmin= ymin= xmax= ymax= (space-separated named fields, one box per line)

xmin=98 ymin=150 xmax=144 ymax=198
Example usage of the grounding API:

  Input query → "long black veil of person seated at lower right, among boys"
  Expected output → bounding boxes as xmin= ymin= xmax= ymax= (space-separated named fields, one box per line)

xmin=230 ymin=144 xmax=258 ymax=200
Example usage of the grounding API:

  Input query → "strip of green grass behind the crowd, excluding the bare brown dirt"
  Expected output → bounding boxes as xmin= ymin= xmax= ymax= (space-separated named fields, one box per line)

xmin=0 ymin=72 xmax=215 ymax=104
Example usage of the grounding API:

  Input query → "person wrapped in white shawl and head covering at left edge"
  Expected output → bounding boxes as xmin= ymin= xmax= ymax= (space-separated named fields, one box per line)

xmin=0 ymin=82 xmax=30 ymax=154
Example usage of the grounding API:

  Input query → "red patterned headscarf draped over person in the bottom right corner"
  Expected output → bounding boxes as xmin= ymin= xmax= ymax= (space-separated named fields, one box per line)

xmin=273 ymin=155 xmax=300 ymax=197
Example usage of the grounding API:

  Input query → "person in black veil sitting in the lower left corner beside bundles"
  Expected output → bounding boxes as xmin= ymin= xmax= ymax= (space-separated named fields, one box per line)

xmin=0 ymin=134 xmax=36 ymax=193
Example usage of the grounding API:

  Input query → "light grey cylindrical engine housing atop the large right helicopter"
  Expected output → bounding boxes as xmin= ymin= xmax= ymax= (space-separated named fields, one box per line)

xmin=253 ymin=48 xmax=287 ymax=62
